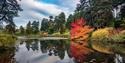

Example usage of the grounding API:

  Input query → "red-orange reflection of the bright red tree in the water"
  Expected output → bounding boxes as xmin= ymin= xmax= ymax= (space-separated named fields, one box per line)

xmin=70 ymin=42 xmax=91 ymax=63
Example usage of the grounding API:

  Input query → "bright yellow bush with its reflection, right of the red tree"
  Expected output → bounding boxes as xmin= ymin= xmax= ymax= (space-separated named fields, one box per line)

xmin=91 ymin=28 xmax=112 ymax=54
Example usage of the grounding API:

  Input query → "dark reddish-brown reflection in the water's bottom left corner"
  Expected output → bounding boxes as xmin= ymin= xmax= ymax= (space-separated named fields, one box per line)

xmin=0 ymin=47 xmax=15 ymax=63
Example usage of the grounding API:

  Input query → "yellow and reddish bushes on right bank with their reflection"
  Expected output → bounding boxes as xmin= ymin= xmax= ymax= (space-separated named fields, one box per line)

xmin=91 ymin=28 xmax=125 ymax=54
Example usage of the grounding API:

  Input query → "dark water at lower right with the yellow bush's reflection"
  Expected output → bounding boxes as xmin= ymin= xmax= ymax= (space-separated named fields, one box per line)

xmin=88 ymin=42 xmax=125 ymax=63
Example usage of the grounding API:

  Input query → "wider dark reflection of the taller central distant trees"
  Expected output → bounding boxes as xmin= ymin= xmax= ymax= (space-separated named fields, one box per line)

xmin=40 ymin=40 xmax=66 ymax=59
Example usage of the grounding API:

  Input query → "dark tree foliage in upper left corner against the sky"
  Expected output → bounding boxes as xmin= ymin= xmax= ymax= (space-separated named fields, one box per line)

xmin=0 ymin=0 xmax=22 ymax=26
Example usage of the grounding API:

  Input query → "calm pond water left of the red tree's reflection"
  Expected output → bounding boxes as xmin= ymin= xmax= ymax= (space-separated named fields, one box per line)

xmin=0 ymin=40 xmax=74 ymax=63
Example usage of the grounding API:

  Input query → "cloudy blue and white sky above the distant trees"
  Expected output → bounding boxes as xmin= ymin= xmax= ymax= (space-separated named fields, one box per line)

xmin=14 ymin=0 xmax=79 ymax=27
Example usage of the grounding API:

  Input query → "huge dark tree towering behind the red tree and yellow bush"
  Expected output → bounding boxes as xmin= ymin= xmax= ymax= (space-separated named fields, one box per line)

xmin=76 ymin=0 xmax=114 ymax=28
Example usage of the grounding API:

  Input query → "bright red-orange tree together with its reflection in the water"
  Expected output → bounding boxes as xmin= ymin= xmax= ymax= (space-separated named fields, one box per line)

xmin=70 ymin=18 xmax=93 ymax=63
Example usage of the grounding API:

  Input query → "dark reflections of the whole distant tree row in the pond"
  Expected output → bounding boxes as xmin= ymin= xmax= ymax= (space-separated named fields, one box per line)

xmin=25 ymin=40 xmax=70 ymax=60
